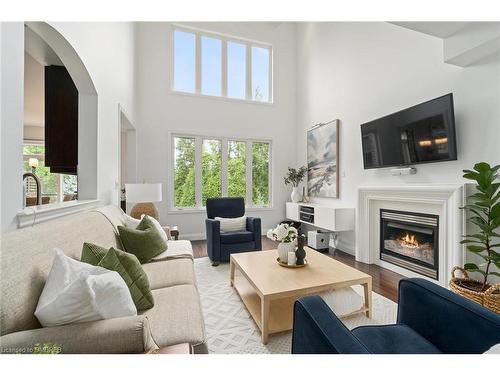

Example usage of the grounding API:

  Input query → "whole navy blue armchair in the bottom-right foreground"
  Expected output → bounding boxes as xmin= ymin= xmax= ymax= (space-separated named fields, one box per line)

xmin=292 ymin=279 xmax=500 ymax=354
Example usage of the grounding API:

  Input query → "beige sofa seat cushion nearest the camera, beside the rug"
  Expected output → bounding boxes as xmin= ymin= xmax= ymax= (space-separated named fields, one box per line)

xmin=141 ymin=285 xmax=205 ymax=347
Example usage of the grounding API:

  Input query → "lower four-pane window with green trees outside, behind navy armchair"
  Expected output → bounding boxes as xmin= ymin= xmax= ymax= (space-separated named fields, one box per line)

xmin=171 ymin=134 xmax=271 ymax=209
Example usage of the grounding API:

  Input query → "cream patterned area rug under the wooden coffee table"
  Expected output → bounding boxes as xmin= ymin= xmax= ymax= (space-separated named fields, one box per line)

xmin=194 ymin=258 xmax=397 ymax=354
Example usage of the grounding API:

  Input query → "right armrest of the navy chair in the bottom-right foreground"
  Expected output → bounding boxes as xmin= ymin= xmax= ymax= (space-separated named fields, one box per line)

xmin=397 ymin=278 xmax=500 ymax=354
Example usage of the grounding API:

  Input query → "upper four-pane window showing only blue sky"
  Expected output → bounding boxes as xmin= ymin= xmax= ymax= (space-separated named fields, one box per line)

xmin=172 ymin=26 xmax=273 ymax=103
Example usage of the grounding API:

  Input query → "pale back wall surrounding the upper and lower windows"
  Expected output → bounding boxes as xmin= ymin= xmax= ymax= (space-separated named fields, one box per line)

xmin=136 ymin=23 xmax=296 ymax=238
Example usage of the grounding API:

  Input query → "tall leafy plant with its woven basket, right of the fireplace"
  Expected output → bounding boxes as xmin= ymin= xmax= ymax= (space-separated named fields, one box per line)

xmin=450 ymin=163 xmax=500 ymax=313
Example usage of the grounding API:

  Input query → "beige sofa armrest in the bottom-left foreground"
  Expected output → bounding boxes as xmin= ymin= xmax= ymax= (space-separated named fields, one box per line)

xmin=0 ymin=315 xmax=158 ymax=354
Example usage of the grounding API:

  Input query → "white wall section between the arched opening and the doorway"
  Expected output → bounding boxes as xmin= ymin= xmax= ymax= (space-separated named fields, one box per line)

xmin=51 ymin=22 xmax=135 ymax=204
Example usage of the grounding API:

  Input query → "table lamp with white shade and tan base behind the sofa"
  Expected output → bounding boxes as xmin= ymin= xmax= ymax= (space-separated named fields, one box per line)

xmin=125 ymin=183 xmax=161 ymax=220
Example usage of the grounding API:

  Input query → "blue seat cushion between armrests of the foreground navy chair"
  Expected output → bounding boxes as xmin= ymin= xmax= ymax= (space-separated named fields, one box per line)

xmin=352 ymin=324 xmax=441 ymax=354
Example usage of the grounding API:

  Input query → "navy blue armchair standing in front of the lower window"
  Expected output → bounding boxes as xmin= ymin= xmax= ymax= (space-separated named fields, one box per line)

xmin=205 ymin=198 xmax=262 ymax=266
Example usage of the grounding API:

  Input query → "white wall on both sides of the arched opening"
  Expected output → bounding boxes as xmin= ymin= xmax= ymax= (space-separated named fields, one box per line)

xmin=1 ymin=22 xmax=135 ymax=231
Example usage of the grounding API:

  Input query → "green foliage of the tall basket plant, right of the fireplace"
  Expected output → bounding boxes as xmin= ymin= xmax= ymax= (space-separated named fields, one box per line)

xmin=460 ymin=163 xmax=500 ymax=291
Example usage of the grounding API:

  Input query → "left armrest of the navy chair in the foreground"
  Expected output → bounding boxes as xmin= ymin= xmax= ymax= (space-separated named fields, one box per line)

xmin=292 ymin=296 xmax=369 ymax=354
